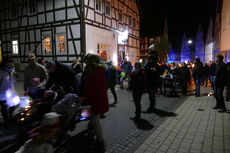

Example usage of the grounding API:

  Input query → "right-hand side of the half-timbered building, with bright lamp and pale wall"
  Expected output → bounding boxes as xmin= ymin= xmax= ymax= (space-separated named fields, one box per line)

xmin=84 ymin=0 xmax=140 ymax=64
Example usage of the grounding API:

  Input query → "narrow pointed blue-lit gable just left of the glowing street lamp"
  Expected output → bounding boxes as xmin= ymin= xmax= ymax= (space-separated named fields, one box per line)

xmin=181 ymin=33 xmax=191 ymax=63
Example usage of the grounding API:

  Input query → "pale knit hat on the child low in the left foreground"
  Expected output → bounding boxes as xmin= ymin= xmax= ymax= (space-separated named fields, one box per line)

xmin=42 ymin=112 xmax=60 ymax=126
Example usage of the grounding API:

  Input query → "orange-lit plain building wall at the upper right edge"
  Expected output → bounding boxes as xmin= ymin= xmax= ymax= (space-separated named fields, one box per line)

xmin=220 ymin=0 xmax=230 ymax=62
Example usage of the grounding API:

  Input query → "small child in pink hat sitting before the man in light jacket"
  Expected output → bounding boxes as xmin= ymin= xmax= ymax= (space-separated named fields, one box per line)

xmin=28 ymin=78 xmax=45 ymax=102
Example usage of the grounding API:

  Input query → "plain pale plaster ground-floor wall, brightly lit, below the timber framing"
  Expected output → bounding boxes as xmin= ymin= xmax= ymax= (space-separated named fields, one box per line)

xmin=86 ymin=25 xmax=118 ymax=64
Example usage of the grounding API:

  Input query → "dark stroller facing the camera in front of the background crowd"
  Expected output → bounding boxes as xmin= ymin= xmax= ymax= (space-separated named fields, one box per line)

xmin=163 ymin=74 xmax=177 ymax=96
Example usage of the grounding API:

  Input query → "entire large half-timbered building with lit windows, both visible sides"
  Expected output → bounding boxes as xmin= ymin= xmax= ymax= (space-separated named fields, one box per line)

xmin=0 ymin=0 xmax=139 ymax=67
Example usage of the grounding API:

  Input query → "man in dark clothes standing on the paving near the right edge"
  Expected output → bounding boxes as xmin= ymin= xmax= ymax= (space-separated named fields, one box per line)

xmin=213 ymin=55 xmax=227 ymax=113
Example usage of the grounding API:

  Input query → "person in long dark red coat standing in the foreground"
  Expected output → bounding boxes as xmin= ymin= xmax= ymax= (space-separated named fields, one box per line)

xmin=80 ymin=54 xmax=109 ymax=150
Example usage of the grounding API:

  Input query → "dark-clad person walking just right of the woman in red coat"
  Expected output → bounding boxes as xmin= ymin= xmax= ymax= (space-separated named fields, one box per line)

xmin=107 ymin=61 xmax=117 ymax=105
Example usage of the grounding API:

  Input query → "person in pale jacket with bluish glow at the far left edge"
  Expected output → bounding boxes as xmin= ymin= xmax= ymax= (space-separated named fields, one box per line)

xmin=0 ymin=57 xmax=15 ymax=127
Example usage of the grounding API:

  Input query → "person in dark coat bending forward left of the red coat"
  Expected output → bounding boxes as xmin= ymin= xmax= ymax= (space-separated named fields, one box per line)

xmin=46 ymin=61 xmax=78 ymax=93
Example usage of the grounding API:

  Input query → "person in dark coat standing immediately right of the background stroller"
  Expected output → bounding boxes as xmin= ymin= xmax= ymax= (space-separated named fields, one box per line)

xmin=178 ymin=63 xmax=191 ymax=95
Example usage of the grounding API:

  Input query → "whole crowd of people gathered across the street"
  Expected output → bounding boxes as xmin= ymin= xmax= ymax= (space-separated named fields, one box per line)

xmin=0 ymin=51 xmax=230 ymax=152
